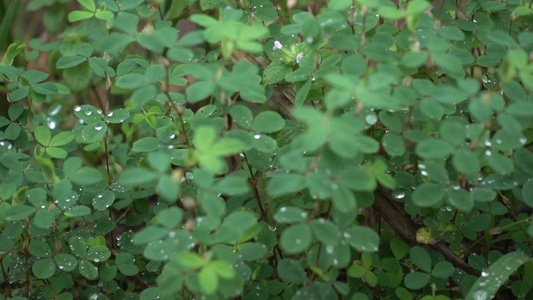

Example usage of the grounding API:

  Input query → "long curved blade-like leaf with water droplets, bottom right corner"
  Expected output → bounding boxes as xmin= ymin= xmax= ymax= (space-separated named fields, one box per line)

xmin=465 ymin=252 xmax=532 ymax=300
